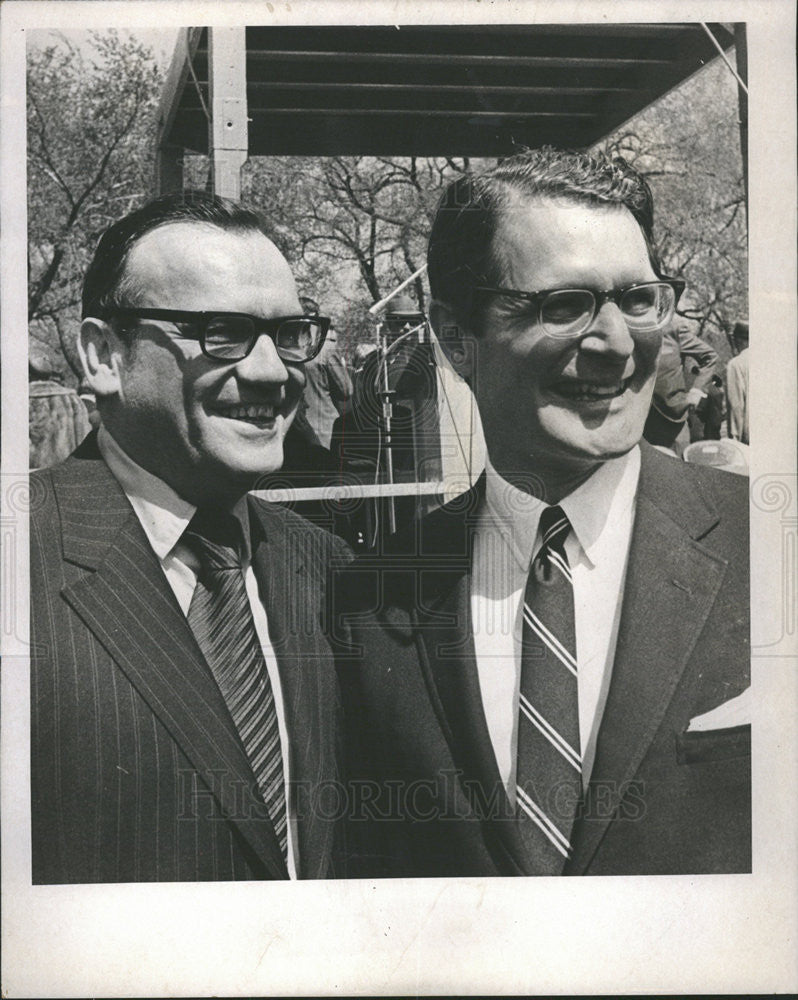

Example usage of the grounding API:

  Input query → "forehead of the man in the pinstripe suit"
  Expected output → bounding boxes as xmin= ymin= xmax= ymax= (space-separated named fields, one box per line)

xmin=125 ymin=222 xmax=299 ymax=315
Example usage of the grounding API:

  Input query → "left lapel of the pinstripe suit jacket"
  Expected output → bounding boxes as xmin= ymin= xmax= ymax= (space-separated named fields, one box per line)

xmin=54 ymin=451 xmax=287 ymax=877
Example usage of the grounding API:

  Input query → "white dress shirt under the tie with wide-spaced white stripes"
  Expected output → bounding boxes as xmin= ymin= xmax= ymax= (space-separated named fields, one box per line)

xmin=471 ymin=448 xmax=640 ymax=802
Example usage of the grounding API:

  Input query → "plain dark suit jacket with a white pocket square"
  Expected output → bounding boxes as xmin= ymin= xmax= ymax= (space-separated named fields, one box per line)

xmin=335 ymin=445 xmax=751 ymax=876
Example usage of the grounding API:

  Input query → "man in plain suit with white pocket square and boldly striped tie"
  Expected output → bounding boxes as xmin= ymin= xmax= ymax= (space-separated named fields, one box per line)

xmin=335 ymin=148 xmax=751 ymax=876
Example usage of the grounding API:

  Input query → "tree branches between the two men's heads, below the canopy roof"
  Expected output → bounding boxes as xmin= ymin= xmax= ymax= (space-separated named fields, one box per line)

xmin=243 ymin=156 xmax=482 ymax=343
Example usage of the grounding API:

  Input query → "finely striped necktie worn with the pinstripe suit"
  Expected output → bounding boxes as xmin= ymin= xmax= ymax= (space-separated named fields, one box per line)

xmin=183 ymin=509 xmax=287 ymax=858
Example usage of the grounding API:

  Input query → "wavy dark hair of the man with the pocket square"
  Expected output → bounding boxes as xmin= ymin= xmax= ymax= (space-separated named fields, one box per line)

xmin=427 ymin=146 xmax=661 ymax=320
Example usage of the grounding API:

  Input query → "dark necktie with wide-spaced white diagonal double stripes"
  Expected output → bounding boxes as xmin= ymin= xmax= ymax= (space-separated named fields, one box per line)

xmin=516 ymin=507 xmax=582 ymax=875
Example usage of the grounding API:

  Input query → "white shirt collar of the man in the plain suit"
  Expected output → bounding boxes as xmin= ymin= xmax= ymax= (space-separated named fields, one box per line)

xmin=485 ymin=446 xmax=640 ymax=568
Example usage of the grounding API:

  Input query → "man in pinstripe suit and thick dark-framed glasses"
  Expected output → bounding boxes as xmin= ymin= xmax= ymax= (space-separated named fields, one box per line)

xmin=31 ymin=192 xmax=348 ymax=883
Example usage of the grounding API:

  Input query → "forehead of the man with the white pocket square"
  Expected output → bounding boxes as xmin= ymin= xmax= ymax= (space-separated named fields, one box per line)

xmin=493 ymin=194 xmax=655 ymax=291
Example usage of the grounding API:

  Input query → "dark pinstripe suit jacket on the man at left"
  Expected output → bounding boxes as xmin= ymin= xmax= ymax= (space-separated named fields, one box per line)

xmin=31 ymin=438 xmax=348 ymax=883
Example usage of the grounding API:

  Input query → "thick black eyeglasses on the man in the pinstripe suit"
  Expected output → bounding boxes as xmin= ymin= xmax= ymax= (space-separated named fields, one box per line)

xmin=98 ymin=306 xmax=330 ymax=365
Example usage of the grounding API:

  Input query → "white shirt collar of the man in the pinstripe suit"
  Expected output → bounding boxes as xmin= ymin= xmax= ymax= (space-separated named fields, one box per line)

xmin=97 ymin=425 xmax=251 ymax=562
